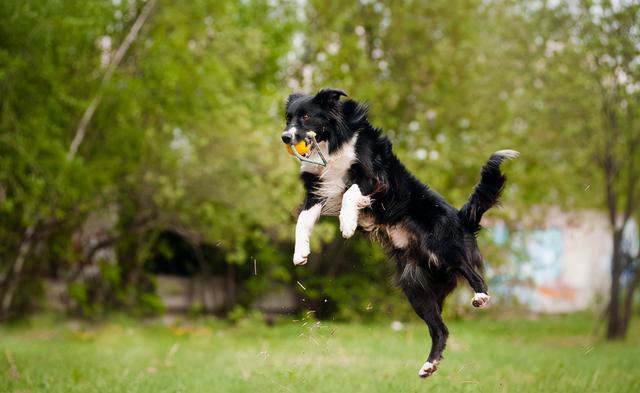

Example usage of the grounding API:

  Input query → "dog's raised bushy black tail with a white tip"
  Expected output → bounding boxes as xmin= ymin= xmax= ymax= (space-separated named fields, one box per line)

xmin=458 ymin=150 xmax=520 ymax=233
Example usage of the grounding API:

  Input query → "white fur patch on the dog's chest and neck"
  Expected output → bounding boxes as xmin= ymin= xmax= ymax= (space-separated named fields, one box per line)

xmin=300 ymin=134 xmax=358 ymax=216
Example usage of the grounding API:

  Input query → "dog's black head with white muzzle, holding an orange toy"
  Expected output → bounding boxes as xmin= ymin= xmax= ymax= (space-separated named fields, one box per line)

xmin=282 ymin=89 xmax=348 ymax=155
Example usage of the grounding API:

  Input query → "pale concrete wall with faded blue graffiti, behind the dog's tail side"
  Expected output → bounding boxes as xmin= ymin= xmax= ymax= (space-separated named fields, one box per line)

xmin=491 ymin=208 xmax=638 ymax=313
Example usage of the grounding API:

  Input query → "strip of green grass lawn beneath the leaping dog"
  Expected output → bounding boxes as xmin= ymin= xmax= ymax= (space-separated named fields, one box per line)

xmin=0 ymin=315 xmax=640 ymax=393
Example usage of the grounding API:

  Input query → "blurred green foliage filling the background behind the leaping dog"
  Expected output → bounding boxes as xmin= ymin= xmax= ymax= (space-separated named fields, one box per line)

xmin=0 ymin=0 xmax=640 ymax=328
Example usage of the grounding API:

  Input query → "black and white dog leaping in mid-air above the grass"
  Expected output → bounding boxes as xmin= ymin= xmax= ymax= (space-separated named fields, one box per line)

xmin=282 ymin=89 xmax=518 ymax=378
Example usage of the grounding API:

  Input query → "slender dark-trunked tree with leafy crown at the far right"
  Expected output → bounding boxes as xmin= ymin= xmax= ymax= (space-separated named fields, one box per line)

xmin=521 ymin=1 xmax=640 ymax=339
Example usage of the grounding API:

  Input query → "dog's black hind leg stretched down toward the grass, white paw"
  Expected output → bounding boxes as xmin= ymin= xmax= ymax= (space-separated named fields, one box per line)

xmin=400 ymin=265 xmax=449 ymax=378
